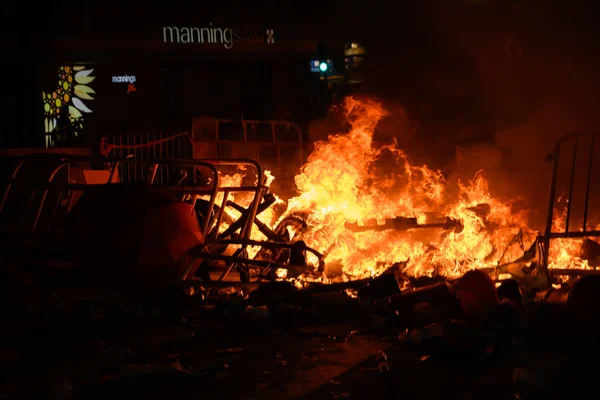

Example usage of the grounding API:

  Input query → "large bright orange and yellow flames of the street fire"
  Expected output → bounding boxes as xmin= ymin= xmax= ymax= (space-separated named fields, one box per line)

xmin=212 ymin=99 xmax=586 ymax=279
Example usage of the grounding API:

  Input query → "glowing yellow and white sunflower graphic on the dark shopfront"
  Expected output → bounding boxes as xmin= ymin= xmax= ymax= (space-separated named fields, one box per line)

xmin=42 ymin=66 xmax=96 ymax=133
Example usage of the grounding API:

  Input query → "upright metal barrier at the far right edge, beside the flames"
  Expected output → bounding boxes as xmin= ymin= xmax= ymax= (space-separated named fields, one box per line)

xmin=541 ymin=132 xmax=600 ymax=275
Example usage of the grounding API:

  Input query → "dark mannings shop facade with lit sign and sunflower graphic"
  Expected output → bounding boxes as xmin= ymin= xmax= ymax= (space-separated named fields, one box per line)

xmin=2 ymin=2 xmax=352 ymax=147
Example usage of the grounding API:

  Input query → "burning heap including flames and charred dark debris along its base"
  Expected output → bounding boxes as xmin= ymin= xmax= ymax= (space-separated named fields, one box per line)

xmin=172 ymin=99 xmax=600 ymax=342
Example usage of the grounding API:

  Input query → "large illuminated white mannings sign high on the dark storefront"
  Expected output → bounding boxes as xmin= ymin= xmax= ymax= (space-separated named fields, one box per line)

xmin=163 ymin=23 xmax=275 ymax=50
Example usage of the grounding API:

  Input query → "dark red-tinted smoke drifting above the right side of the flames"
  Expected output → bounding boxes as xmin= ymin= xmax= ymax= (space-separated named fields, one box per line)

xmin=350 ymin=0 xmax=600 ymax=229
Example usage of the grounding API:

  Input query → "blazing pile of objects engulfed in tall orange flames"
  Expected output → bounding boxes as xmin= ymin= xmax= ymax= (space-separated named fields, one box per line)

xmin=197 ymin=99 xmax=597 ymax=289
